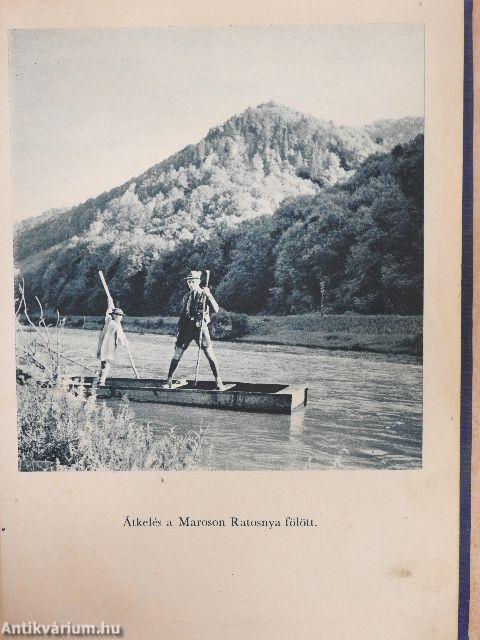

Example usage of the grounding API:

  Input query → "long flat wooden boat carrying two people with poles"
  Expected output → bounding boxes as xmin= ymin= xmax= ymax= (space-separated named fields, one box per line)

xmin=70 ymin=376 xmax=308 ymax=414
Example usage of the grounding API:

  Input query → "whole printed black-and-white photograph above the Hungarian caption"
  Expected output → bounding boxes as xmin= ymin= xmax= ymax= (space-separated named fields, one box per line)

xmin=8 ymin=23 xmax=428 ymax=470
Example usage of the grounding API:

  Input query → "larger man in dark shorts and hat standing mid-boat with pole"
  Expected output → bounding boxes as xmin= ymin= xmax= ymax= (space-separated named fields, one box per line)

xmin=166 ymin=271 xmax=225 ymax=391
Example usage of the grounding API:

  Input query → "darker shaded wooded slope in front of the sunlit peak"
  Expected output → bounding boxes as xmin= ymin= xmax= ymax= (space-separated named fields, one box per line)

xmin=145 ymin=135 xmax=423 ymax=314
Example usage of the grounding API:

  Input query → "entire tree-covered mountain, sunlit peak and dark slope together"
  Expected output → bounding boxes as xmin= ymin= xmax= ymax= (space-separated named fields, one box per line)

xmin=15 ymin=103 xmax=423 ymax=315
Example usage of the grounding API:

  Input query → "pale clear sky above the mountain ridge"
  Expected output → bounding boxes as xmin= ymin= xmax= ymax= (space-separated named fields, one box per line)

xmin=9 ymin=25 xmax=424 ymax=221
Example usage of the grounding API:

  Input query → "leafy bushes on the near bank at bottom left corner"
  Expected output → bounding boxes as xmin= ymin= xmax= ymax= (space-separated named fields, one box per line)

xmin=17 ymin=380 xmax=202 ymax=471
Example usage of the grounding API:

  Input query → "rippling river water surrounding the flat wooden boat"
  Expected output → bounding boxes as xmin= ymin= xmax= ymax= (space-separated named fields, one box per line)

xmin=61 ymin=329 xmax=422 ymax=470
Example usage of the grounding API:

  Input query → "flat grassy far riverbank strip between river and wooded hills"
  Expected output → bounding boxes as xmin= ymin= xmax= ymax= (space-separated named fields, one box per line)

xmin=25 ymin=311 xmax=423 ymax=356
